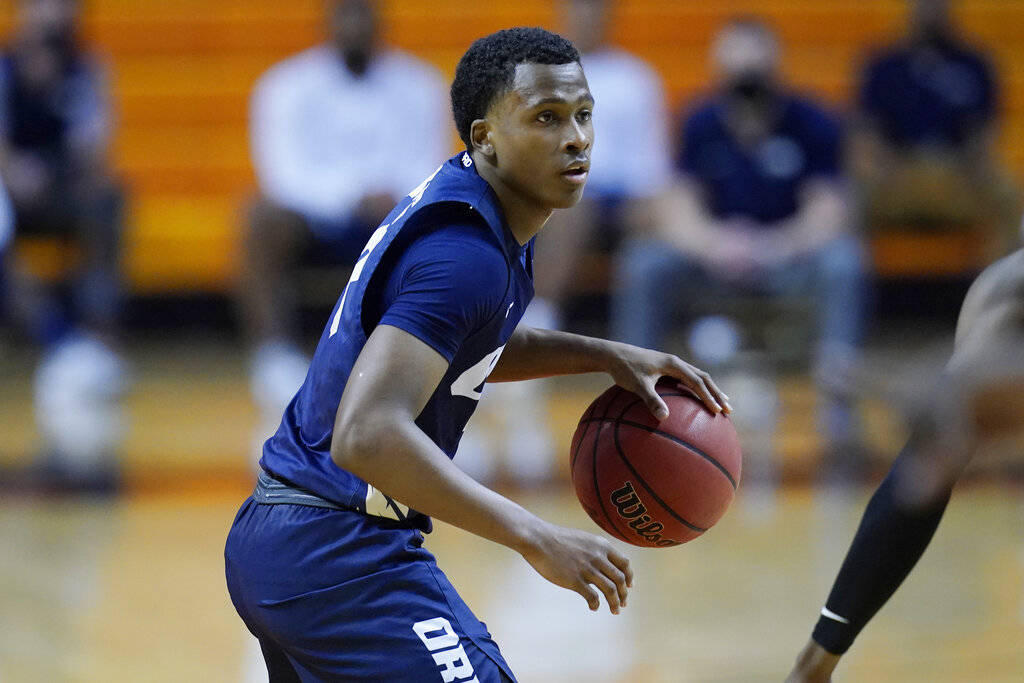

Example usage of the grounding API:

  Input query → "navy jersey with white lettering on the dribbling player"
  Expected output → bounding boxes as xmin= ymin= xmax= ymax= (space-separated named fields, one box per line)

xmin=260 ymin=153 xmax=534 ymax=530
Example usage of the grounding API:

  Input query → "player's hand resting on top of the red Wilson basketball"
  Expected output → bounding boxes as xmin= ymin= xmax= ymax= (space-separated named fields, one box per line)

xmin=607 ymin=344 xmax=732 ymax=420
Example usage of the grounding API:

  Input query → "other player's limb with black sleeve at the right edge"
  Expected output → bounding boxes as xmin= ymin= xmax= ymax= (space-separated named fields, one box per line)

xmin=787 ymin=250 xmax=1024 ymax=683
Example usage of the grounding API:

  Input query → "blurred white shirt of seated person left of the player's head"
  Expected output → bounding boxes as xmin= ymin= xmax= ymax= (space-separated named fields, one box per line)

xmin=250 ymin=45 xmax=450 ymax=221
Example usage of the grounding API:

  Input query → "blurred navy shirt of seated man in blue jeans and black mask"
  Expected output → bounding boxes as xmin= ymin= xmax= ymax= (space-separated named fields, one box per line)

xmin=676 ymin=96 xmax=841 ymax=225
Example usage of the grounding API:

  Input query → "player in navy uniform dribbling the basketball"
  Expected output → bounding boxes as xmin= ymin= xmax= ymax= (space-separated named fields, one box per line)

xmin=225 ymin=29 xmax=729 ymax=682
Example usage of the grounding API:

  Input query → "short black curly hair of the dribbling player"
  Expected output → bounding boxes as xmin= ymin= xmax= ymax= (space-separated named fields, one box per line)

xmin=452 ymin=27 xmax=580 ymax=150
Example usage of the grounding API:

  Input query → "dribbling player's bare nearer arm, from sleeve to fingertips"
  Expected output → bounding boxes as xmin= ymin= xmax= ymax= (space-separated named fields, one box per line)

xmin=331 ymin=325 xmax=633 ymax=613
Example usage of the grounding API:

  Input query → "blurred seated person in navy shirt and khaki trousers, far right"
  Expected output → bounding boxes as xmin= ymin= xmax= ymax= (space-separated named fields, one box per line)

xmin=851 ymin=0 xmax=1021 ymax=266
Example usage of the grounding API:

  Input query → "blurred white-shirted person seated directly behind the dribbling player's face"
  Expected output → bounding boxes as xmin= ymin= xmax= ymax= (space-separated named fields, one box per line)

xmin=459 ymin=0 xmax=672 ymax=485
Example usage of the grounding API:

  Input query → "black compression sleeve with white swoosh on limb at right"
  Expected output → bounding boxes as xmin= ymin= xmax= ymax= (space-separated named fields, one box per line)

xmin=812 ymin=441 xmax=951 ymax=654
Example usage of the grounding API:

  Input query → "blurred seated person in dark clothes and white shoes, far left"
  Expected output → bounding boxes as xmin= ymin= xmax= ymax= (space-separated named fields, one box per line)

xmin=0 ymin=0 xmax=124 ymax=492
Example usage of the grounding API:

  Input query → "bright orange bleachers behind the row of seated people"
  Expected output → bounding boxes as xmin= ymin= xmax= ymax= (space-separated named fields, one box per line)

xmin=0 ymin=0 xmax=1024 ymax=294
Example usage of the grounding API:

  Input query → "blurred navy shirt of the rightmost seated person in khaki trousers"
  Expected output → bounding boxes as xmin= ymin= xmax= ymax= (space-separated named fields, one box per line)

xmin=859 ymin=41 xmax=995 ymax=146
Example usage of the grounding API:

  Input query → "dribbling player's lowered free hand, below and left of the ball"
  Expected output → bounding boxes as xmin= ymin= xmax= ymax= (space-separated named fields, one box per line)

xmin=522 ymin=522 xmax=633 ymax=614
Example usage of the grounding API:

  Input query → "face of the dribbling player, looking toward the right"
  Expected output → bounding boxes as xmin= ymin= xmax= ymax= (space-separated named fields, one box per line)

xmin=487 ymin=62 xmax=594 ymax=209
